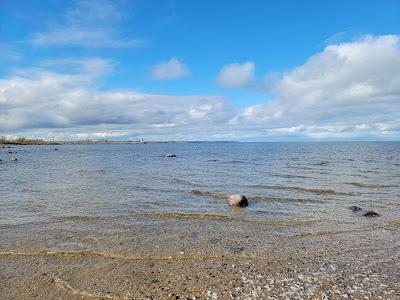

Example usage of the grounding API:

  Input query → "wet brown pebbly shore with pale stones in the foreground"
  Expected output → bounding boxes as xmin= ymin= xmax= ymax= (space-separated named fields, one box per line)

xmin=0 ymin=219 xmax=400 ymax=299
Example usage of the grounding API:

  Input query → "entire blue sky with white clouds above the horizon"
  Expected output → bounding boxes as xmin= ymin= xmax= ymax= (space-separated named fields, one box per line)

xmin=0 ymin=0 xmax=400 ymax=141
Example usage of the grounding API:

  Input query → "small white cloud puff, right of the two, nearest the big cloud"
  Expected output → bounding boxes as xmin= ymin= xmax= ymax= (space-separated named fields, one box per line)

xmin=216 ymin=62 xmax=254 ymax=88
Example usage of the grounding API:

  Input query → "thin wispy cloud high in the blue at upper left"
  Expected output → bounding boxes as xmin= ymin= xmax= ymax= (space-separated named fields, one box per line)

xmin=29 ymin=0 xmax=146 ymax=48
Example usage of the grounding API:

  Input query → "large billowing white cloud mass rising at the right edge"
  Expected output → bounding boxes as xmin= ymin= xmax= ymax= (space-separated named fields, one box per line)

xmin=236 ymin=35 xmax=400 ymax=137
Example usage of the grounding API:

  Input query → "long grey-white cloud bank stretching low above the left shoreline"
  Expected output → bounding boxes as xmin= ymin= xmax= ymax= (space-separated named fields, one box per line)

xmin=0 ymin=63 xmax=234 ymax=138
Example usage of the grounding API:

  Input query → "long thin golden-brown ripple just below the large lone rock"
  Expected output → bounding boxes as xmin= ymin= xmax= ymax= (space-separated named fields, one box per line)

xmin=154 ymin=213 xmax=315 ymax=226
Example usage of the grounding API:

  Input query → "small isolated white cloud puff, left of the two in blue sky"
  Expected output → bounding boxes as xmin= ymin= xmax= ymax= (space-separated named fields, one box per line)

xmin=151 ymin=57 xmax=190 ymax=80
